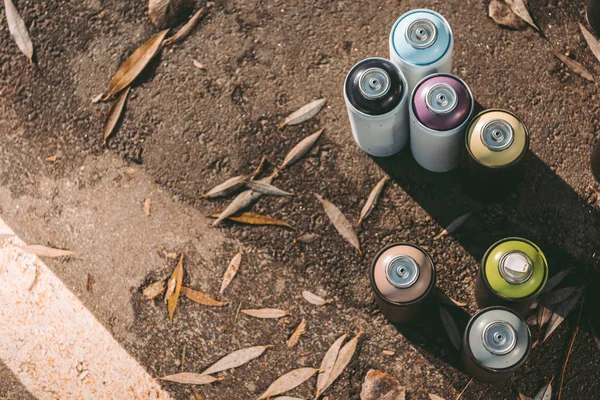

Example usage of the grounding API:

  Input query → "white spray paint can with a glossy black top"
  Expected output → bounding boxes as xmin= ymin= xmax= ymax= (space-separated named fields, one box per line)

xmin=344 ymin=58 xmax=409 ymax=157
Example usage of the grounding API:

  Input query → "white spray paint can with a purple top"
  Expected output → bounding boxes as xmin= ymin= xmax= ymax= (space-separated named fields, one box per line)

xmin=409 ymin=74 xmax=475 ymax=172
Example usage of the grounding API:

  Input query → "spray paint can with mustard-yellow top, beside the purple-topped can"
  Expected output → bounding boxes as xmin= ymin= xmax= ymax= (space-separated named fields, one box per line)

xmin=463 ymin=109 xmax=529 ymax=199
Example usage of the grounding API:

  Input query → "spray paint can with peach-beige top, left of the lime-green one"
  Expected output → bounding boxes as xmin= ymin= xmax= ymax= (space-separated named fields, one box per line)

xmin=370 ymin=243 xmax=435 ymax=323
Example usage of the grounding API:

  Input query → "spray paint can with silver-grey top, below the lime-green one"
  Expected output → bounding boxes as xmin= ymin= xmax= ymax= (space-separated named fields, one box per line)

xmin=461 ymin=306 xmax=531 ymax=382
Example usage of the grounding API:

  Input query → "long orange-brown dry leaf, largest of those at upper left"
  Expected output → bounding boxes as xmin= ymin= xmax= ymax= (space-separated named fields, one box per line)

xmin=102 ymin=29 xmax=169 ymax=101
